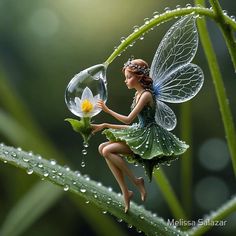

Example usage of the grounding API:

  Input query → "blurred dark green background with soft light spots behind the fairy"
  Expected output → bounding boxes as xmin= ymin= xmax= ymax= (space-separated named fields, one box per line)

xmin=0 ymin=0 xmax=236 ymax=236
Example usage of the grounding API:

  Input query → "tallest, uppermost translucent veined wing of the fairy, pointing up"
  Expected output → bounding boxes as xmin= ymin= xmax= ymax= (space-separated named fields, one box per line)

xmin=150 ymin=15 xmax=198 ymax=85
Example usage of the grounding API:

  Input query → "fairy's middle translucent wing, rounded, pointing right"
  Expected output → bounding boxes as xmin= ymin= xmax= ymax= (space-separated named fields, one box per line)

xmin=154 ymin=63 xmax=204 ymax=103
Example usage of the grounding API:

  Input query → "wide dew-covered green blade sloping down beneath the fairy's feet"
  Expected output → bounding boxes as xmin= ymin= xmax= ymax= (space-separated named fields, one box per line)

xmin=0 ymin=144 xmax=184 ymax=235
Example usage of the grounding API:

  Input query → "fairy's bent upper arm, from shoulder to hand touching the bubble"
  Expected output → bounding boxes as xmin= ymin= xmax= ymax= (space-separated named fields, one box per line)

xmin=98 ymin=91 xmax=152 ymax=124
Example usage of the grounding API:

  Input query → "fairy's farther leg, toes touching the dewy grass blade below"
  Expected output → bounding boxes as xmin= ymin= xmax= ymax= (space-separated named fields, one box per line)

xmin=98 ymin=142 xmax=133 ymax=213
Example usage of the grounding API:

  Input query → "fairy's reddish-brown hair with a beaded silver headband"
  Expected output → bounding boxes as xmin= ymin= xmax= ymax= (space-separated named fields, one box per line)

xmin=122 ymin=59 xmax=153 ymax=90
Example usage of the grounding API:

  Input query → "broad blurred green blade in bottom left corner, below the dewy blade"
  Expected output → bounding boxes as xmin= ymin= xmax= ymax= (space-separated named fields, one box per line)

xmin=0 ymin=182 xmax=63 ymax=236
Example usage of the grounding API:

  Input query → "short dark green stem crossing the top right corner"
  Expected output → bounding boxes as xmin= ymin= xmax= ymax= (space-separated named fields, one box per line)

xmin=210 ymin=0 xmax=236 ymax=71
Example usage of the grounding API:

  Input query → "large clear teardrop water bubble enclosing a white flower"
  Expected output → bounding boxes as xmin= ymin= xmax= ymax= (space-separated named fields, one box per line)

xmin=65 ymin=64 xmax=107 ymax=117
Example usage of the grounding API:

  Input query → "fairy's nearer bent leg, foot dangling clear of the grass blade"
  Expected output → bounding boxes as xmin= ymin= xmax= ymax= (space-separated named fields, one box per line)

xmin=102 ymin=142 xmax=147 ymax=201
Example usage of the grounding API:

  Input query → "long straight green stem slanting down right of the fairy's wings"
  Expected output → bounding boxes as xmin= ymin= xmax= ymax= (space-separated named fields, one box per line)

xmin=195 ymin=0 xmax=236 ymax=175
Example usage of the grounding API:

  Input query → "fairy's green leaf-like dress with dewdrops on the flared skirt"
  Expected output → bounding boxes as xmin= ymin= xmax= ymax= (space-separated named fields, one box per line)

xmin=103 ymin=91 xmax=189 ymax=181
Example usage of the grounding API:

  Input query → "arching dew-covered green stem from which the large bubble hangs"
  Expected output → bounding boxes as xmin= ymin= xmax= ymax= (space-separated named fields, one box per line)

xmin=105 ymin=7 xmax=236 ymax=65
